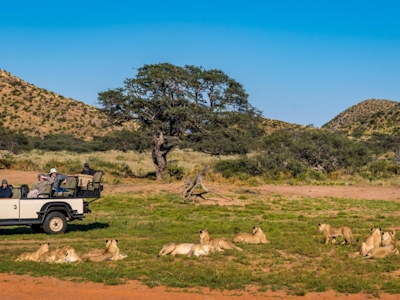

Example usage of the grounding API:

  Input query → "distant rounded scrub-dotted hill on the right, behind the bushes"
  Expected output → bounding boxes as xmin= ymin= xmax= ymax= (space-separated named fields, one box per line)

xmin=322 ymin=99 xmax=400 ymax=138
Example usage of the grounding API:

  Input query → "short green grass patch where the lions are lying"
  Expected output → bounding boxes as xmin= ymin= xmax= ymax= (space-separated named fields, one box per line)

xmin=0 ymin=189 xmax=400 ymax=296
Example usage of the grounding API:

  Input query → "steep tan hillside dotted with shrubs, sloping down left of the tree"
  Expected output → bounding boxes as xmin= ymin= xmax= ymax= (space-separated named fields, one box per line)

xmin=0 ymin=69 xmax=126 ymax=140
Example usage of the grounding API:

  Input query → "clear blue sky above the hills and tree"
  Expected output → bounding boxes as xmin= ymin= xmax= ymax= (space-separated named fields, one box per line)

xmin=0 ymin=0 xmax=400 ymax=127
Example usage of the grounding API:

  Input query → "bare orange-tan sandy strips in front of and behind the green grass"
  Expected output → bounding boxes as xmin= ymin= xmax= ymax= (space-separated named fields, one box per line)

xmin=0 ymin=170 xmax=400 ymax=300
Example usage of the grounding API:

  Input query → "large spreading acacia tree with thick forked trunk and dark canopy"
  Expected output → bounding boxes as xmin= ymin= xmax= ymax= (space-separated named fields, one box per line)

xmin=98 ymin=63 xmax=262 ymax=179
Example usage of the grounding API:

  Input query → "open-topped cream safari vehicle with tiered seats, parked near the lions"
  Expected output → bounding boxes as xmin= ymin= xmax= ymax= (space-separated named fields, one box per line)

xmin=0 ymin=171 xmax=103 ymax=234
